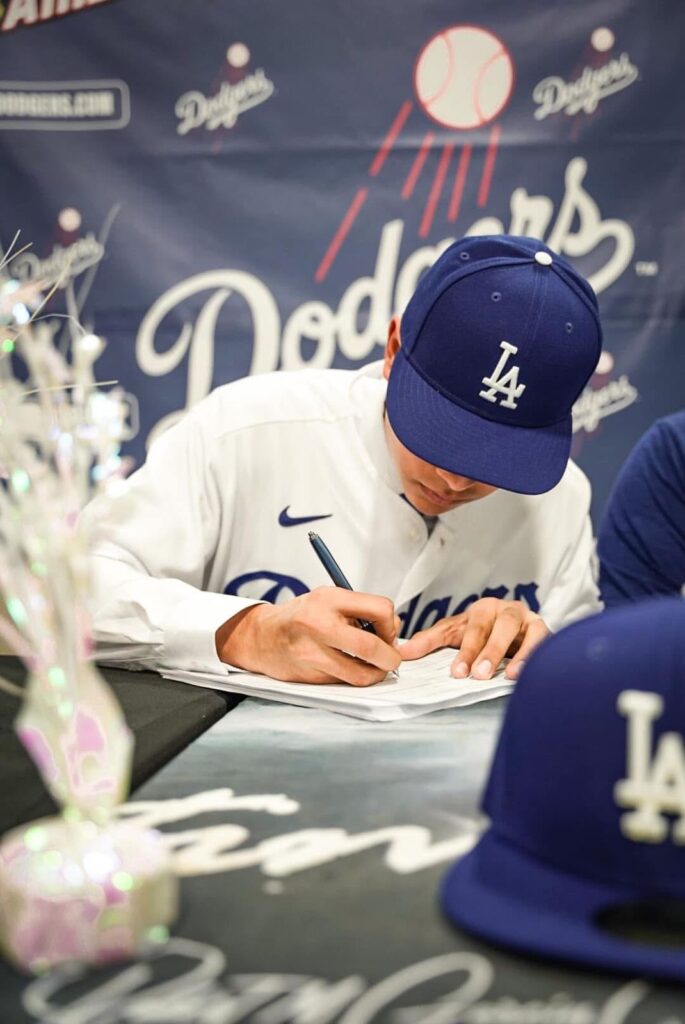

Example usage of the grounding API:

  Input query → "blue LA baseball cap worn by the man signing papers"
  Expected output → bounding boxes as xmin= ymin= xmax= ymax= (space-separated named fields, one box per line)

xmin=387 ymin=234 xmax=602 ymax=494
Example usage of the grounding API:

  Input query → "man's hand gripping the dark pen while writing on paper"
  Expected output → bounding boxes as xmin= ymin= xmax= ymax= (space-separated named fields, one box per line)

xmin=215 ymin=587 xmax=401 ymax=686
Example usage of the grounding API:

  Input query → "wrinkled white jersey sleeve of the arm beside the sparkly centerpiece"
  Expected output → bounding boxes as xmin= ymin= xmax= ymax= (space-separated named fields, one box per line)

xmin=83 ymin=399 xmax=262 ymax=672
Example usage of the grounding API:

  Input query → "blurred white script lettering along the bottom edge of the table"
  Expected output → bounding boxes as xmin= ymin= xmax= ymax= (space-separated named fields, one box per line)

xmin=23 ymin=938 xmax=651 ymax=1024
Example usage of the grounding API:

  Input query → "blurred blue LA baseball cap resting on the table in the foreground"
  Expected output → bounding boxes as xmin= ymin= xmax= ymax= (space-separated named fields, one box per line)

xmin=441 ymin=598 xmax=685 ymax=981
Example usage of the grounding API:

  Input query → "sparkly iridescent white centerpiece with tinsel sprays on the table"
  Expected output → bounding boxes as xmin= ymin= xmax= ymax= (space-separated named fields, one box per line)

xmin=0 ymin=235 xmax=177 ymax=972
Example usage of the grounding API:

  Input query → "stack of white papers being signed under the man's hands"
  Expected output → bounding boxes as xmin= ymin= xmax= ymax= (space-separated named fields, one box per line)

xmin=164 ymin=648 xmax=513 ymax=722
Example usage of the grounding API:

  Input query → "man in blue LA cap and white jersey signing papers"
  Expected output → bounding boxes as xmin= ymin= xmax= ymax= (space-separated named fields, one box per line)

xmin=87 ymin=236 xmax=601 ymax=686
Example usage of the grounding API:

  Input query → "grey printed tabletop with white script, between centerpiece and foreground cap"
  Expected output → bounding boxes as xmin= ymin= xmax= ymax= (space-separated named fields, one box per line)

xmin=0 ymin=699 xmax=685 ymax=1024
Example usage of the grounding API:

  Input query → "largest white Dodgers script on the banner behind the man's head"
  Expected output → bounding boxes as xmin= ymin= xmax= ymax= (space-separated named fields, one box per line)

xmin=136 ymin=157 xmax=635 ymax=442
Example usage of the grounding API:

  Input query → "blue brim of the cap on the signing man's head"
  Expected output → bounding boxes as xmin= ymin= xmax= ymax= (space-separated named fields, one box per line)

xmin=387 ymin=348 xmax=571 ymax=495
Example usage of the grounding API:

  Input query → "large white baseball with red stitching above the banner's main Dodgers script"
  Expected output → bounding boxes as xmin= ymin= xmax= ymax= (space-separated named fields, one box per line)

xmin=414 ymin=25 xmax=514 ymax=131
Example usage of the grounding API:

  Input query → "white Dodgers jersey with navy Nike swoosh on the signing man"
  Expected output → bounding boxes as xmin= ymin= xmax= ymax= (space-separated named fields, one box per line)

xmin=84 ymin=364 xmax=599 ymax=671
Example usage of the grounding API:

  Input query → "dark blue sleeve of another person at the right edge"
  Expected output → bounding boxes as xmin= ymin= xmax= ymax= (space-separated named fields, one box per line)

xmin=597 ymin=412 xmax=685 ymax=608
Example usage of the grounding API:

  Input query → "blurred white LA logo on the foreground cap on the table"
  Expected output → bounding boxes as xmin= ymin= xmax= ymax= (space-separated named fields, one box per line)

xmin=613 ymin=690 xmax=685 ymax=845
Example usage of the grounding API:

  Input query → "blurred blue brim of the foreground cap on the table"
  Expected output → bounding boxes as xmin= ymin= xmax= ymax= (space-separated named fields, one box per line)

xmin=440 ymin=829 xmax=685 ymax=982
